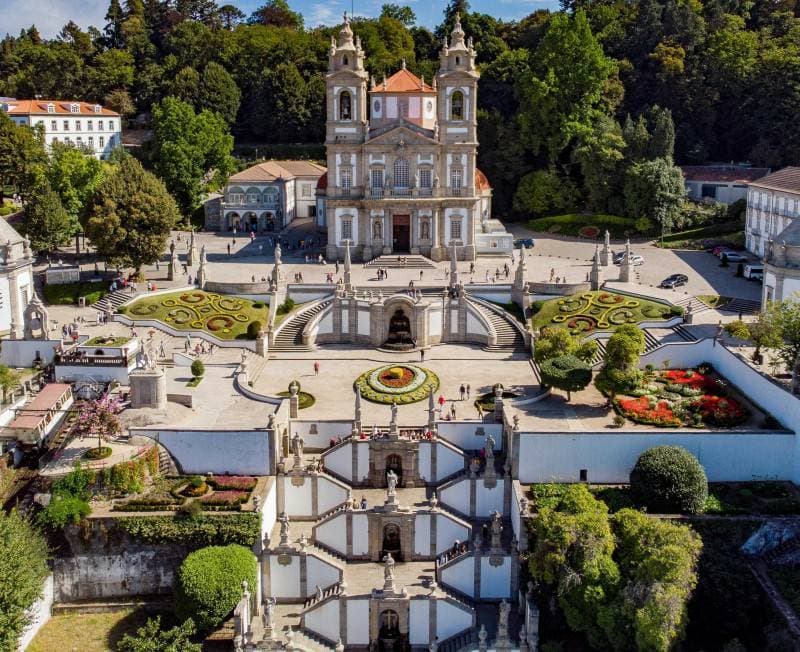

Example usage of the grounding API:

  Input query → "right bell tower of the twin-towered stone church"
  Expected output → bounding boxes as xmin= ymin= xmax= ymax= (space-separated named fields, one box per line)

xmin=436 ymin=14 xmax=479 ymax=144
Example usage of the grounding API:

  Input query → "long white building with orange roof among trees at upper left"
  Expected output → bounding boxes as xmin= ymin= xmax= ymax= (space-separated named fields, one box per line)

xmin=0 ymin=98 xmax=122 ymax=159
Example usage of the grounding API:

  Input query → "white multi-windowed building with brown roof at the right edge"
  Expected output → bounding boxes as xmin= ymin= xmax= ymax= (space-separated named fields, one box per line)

xmin=745 ymin=167 xmax=800 ymax=257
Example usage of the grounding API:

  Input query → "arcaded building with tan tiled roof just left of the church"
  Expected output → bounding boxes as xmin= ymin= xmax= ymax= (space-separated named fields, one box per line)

xmin=206 ymin=161 xmax=332 ymax=231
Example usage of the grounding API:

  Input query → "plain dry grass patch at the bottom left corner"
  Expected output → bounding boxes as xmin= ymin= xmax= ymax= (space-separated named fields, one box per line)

xmin=28 ymin=609 xmax=152 ymax=652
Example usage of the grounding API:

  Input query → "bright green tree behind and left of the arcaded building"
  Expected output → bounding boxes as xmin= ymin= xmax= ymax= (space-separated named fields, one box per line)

xmin=151 ymin=97 xmax=233 ymax=215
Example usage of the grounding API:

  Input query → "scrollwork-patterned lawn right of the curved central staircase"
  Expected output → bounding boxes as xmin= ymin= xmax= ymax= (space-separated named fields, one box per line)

xmin=533 ymin=291 xmax=680 ymax=335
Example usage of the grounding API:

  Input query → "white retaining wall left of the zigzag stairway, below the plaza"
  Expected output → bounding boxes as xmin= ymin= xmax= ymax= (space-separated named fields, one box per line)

xmin=130 ymin=428 xmax=271 ymax=475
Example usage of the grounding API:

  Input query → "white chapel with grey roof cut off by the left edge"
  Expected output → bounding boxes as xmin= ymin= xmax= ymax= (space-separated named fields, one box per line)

xmin=0 ymin=218 xmax=33 ymax=338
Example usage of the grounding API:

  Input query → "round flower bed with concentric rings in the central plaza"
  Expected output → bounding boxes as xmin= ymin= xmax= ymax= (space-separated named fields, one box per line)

xmin=355 ymin=364 xmax=439 ymax=405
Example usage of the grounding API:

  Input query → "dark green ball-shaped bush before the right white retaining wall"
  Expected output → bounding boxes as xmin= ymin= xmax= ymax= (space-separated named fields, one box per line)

xmin=630 ymin=446 xmax=708 ymax=514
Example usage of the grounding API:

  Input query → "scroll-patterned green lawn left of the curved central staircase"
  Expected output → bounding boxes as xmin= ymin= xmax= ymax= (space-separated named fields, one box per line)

xmin=123 ymin=290 xmax=267 ymax=340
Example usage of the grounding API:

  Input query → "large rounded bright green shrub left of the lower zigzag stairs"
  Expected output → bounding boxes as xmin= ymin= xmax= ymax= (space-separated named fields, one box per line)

xmin=175 ymin=545 xmax=256 ymax=631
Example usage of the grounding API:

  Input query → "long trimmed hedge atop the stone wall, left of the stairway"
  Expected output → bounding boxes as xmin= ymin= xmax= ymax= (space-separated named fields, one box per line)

xmin=117 ymin=512 xmax=261 ymax=548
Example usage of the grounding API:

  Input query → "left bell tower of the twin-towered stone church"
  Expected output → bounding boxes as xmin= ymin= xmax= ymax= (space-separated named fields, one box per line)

xmin=325 ymin=14 xmax=369 ymax=144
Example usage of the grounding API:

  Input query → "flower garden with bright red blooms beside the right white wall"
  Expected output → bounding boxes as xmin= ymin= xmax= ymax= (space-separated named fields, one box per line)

xmin=614 ymin=365 xmax=750 ymax=428
